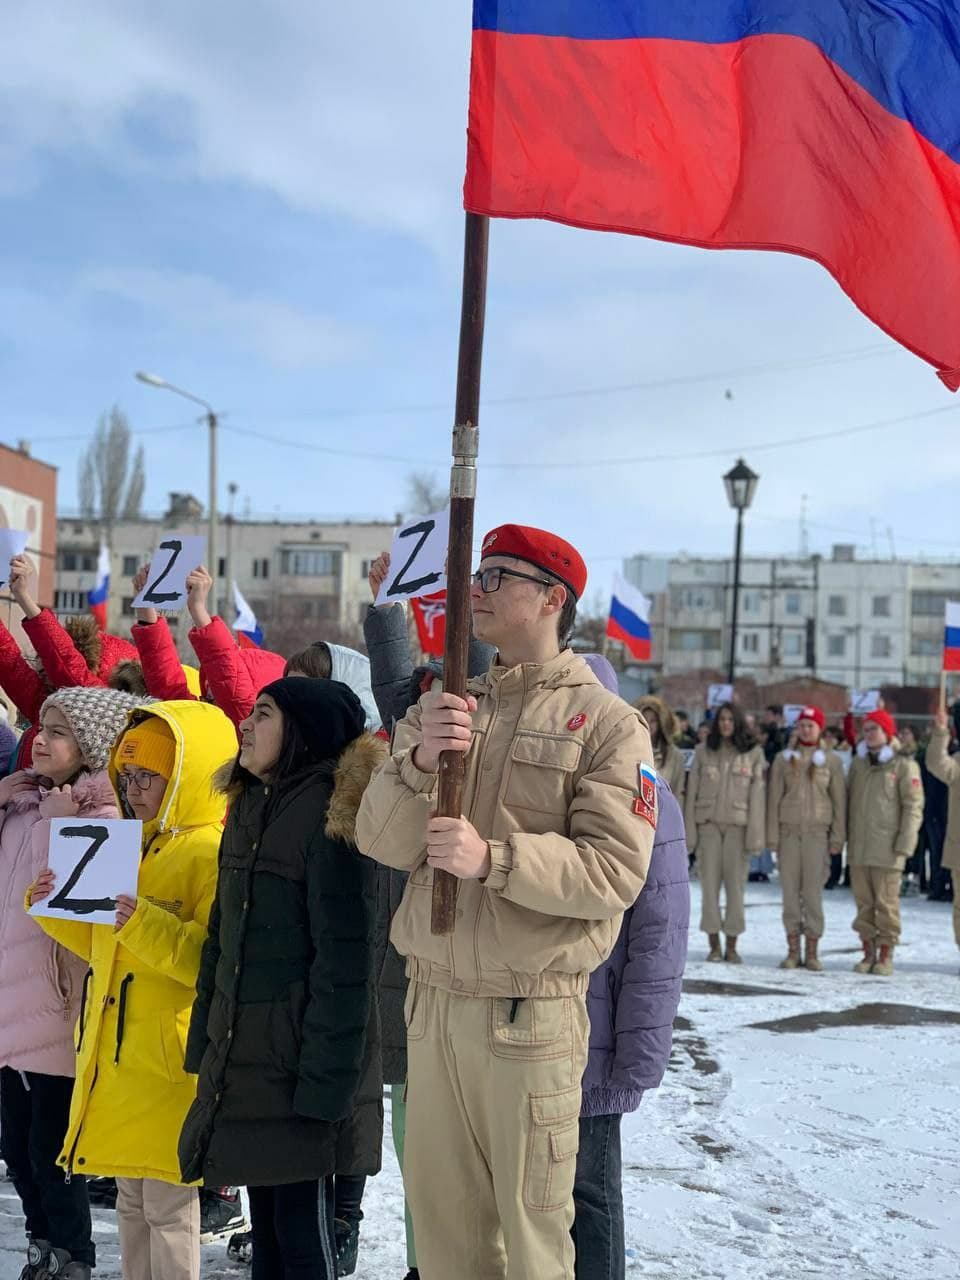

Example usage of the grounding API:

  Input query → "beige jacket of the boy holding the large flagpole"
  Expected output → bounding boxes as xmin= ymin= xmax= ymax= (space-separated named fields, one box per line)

xmin=357 ymin=650 xmax=654 ymax=997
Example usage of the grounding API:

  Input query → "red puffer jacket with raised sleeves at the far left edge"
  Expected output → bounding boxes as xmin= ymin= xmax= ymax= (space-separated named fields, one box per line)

xmin=0 ymin=609 xmax=137 ymax=769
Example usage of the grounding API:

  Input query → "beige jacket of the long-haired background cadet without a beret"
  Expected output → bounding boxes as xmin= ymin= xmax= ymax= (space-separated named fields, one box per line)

xmin=684 ymin=742 xmax=767 ymax=854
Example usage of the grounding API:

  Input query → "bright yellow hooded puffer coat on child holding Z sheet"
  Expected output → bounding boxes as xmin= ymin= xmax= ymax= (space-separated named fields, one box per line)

xmin=37 ymin=701 xmax=237 ymax=1183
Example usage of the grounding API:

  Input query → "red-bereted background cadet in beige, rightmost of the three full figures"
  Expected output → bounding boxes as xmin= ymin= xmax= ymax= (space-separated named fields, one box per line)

xmin=846 ymin=710 xmax=923 ymax=978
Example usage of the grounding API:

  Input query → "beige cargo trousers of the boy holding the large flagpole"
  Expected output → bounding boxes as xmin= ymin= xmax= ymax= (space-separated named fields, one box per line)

xmin=403 ymin=982 xmax=590 ymax=1280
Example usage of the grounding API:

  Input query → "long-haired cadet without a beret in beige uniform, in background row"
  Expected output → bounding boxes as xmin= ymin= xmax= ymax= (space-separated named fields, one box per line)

xmin=684 ymin=703 xmax=765 ymax=964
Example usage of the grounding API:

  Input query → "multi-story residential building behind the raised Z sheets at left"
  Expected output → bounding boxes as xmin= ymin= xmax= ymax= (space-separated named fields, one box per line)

xmin=52 ymin=494 xmax=394 ymax=654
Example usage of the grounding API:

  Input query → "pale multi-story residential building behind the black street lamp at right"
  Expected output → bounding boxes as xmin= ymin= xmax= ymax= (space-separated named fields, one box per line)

xmin=623 ymin=544 xmax=960 ymax=689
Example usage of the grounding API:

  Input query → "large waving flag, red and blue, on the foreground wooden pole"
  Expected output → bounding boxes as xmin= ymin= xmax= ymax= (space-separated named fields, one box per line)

xmin=465 ymin=0 xmax=960 ymax=390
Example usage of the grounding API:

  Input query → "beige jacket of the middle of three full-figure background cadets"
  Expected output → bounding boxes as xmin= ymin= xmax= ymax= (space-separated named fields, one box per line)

xmin=767 ymin=746 xmax=846 ymax=854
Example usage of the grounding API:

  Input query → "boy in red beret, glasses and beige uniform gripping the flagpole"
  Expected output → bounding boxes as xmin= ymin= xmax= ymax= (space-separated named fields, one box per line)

xmin=357 ymin=525 xmax=657 ymax=1280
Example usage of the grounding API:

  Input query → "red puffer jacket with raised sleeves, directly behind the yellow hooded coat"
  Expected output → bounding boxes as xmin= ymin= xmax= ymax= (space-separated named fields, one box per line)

xmin=133 ymin=618 xmax=287 ymax=726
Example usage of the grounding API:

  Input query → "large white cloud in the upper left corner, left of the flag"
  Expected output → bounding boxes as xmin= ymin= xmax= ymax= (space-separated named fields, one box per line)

xmin=0 ymin=0 xmax=470 ymax=247
